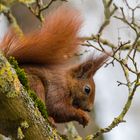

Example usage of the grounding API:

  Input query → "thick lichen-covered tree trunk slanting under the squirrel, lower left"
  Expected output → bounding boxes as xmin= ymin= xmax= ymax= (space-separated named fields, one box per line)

xmin=0 ymin=53 xmax=61 ymax=140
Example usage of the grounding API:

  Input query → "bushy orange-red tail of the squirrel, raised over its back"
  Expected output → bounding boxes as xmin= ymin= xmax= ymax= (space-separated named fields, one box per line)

xmin=0 ymin=6 xmax=82 ymax=64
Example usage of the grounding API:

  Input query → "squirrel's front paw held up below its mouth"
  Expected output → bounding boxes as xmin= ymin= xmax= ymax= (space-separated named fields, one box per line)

xmin=78 ymin=110 xmax=90 ymax=127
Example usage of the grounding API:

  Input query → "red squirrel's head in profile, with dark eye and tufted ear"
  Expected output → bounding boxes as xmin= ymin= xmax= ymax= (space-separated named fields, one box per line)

xmin=68 ymin=54 xmax=108 ymax=112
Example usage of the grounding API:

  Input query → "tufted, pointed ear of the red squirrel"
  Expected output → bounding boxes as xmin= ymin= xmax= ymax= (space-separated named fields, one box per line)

xmin=71 ymin=54 xmax=108 ymax=79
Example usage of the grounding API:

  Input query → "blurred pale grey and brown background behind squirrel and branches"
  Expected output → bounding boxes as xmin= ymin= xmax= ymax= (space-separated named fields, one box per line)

xmin=0 ymin=0 xmax=140 ymax=140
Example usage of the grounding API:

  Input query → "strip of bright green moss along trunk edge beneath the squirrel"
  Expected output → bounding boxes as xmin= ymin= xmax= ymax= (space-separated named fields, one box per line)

xmin=9 ymin=57 xmax=48 ymax=119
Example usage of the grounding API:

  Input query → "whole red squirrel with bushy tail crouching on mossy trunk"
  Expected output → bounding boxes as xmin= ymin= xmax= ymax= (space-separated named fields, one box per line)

xmin=0 ymin=6 xmax=108 ymax=126
